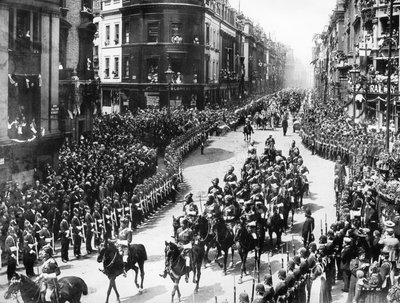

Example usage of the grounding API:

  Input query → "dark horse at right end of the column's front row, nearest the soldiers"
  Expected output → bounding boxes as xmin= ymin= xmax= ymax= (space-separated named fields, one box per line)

xmin=234 ymin=222 xmax=257 ymax=284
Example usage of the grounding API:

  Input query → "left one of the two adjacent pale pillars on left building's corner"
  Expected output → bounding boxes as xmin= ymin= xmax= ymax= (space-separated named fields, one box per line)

xmin=40 ymin=12 xmax=50 ymax=135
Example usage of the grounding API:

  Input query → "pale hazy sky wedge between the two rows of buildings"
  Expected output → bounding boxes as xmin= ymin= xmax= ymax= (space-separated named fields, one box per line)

xmin=229 ymin=0 xmax=336 ymax=62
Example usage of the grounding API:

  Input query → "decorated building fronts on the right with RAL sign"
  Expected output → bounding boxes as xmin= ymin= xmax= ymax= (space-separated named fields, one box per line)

xmin=313 ymin=0 xmax=400 ymax=130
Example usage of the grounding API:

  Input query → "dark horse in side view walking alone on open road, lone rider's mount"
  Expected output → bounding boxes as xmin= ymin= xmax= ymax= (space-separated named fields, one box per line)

xmin=97 ymin=240 xmax=147 ymax=302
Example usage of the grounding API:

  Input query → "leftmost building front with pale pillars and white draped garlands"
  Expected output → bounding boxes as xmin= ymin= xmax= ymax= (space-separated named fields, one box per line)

xmin=0 ymin=0 xmax=63 ymax=184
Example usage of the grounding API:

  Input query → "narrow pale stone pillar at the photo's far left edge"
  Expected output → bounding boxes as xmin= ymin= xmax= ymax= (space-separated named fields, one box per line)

xmin=0 ymin=4 xmax=9 ymax=141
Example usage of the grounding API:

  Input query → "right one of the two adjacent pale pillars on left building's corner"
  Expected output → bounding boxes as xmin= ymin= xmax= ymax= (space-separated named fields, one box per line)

xmin=49 ymin=14 xmax=60 ymax=133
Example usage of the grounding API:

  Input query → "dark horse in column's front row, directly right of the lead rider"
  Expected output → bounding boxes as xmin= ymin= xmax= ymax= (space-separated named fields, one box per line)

xmin=211 ymin=217 xmax=235 ymax=275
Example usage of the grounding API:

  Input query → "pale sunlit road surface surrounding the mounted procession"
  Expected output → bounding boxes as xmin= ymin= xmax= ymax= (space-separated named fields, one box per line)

xmin=0 ymin=121 xmax=346 ymax=303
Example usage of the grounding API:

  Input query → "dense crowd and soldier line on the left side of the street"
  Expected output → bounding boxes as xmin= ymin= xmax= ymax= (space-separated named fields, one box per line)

xmin=0 ymin=92 xmax=278 ymax=279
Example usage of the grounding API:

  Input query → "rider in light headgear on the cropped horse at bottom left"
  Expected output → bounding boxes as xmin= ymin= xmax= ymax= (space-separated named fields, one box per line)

xmin=38 ymin=245 xmax=61 ymax=302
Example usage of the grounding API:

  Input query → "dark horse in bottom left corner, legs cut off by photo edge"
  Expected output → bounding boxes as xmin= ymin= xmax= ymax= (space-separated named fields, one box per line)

xmin=4 ymin=274 xmax=88 ymax=303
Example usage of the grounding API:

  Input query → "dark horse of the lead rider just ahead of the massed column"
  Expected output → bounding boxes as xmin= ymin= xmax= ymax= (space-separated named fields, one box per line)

xmin=164 ymin=241 xmax=204 ymax=302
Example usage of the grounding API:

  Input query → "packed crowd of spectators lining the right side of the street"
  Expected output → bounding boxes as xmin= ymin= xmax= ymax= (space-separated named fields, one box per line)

xmin=296 ymin=89 xmax=400 ymax=303
